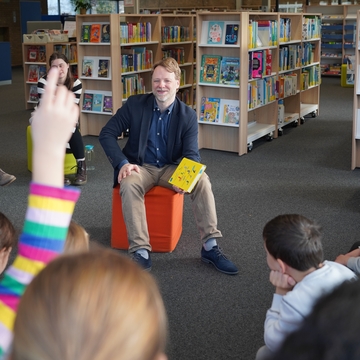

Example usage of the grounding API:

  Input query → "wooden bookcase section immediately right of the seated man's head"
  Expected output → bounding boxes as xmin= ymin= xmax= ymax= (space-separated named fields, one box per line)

xmin=161 ymin=14 xmax=195 ymax=107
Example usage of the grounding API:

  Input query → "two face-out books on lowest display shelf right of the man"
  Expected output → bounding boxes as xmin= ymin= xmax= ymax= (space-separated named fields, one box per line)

xmin=200 ymin=97 xmax=240 ymax=125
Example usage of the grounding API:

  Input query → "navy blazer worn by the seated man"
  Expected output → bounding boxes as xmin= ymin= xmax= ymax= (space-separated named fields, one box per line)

xmin=99 ymin=93 xmax=200 ymax=186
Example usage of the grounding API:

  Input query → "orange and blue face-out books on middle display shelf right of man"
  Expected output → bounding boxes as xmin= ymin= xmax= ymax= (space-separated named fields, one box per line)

xmin=200 ymin=54 xmax=240 ymax=85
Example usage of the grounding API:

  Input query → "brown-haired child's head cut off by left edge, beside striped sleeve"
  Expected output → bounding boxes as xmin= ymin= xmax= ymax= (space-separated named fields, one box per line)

xmin=0 ymin=212 xmax=17 ymax=274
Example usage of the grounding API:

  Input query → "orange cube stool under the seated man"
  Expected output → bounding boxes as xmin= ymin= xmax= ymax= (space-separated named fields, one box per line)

xmin=111 ymin=185 xmax=184 ymax=252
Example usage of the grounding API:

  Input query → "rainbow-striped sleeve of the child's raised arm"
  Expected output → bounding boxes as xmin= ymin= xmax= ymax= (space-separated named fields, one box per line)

xmin=0 ymin=183 xmax=80 ymax=357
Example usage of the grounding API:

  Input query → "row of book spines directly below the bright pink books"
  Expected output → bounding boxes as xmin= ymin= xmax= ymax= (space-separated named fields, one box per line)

xmin=248 ymin=76 xmax=277 ymax=110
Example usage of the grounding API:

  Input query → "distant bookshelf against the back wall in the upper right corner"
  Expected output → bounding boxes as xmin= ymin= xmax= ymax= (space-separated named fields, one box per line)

xmin=305 ymin=5 xmax=360 ymax=76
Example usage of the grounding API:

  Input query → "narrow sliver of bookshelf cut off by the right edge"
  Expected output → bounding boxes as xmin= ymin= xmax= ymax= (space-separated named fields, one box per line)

xmin=351 ymin=10 xmax=360 ymax=170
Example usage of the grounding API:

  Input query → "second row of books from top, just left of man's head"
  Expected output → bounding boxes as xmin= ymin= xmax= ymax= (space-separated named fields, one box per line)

xmin=120 ymin=46 xmax=153 ymax=72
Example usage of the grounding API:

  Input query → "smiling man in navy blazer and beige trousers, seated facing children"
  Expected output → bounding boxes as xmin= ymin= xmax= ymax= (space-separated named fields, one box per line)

xmin=99 ymin=58 xmax=238 ymax=275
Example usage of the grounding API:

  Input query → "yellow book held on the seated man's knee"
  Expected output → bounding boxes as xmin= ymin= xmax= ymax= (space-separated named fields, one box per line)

xmin=169 ymin=158 xmax=206 ymax=193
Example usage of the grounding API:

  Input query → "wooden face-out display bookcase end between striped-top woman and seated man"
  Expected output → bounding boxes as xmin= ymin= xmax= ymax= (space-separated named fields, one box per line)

xmin=76 ymin=14 xmax=122 ymax=135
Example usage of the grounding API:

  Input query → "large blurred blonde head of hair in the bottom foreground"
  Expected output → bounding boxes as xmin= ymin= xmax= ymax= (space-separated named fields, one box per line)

xmin=11 ymin=248 xmax=167 ymax=360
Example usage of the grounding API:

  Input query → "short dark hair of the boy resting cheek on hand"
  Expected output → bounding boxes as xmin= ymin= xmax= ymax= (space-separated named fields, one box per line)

xmin=263 ymin=214 xmax=323 ymax=271
